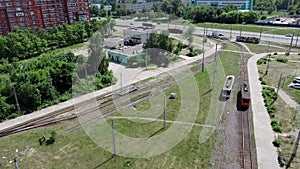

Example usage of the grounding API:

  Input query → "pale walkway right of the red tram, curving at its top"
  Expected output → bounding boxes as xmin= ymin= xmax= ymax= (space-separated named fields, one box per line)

xmin=247 ymin=53 xmax=280 ymax=169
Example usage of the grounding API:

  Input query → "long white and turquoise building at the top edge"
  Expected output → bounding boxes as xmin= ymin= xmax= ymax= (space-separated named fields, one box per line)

xmin=189 ymin=0 xmax=253 ymax=10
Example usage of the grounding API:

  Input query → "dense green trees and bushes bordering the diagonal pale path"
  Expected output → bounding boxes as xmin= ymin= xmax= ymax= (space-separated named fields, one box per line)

xmin=0 ymin=29 xmax=114 ymax=121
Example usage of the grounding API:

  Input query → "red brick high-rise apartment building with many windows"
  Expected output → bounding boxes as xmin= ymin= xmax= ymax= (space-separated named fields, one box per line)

xmin=0 ymin=0 xmax=90 ymax=35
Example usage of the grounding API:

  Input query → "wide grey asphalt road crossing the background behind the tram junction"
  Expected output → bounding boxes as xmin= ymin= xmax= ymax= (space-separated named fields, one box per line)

xmin=116 ymin=19 xmax=300 ymax=46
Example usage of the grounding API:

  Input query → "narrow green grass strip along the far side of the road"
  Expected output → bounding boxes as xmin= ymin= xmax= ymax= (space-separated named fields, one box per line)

xmin=196 ymin=23 xmax=298 ymax=36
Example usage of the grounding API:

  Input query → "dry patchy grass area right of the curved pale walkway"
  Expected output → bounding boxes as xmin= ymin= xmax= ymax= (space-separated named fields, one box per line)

xmin=258 ymin=55 xmax=300 ymax=168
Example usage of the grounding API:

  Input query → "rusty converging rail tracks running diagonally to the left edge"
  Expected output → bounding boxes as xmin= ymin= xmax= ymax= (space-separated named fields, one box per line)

xmin=0 ymin=54 xmax=218 ymax=138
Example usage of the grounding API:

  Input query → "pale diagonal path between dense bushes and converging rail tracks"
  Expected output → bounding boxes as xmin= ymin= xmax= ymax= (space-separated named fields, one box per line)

xmin=0 ymin=48 xmax=215 ymax=132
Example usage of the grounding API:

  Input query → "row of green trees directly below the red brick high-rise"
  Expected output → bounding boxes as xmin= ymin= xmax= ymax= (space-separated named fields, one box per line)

xmin=0 ymin=19 xmax=114 ymax=62
